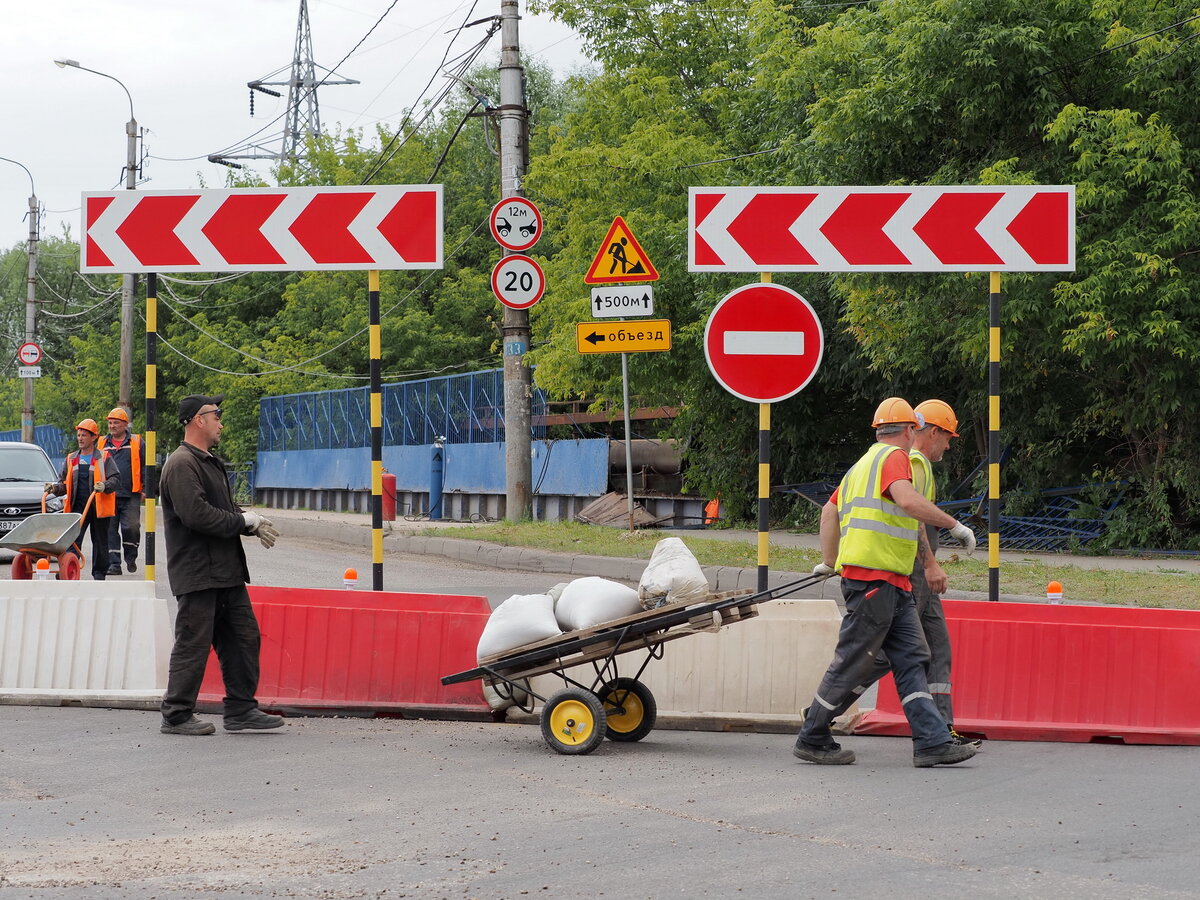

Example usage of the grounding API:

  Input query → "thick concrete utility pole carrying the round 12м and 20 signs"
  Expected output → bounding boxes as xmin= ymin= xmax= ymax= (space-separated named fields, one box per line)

xmin=497 ymin=0 xmax=533 ymax=522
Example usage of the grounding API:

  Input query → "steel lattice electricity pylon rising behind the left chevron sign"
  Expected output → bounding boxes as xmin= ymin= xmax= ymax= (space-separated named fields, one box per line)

xmin=209 ymin=0 xmax=358 ymax=168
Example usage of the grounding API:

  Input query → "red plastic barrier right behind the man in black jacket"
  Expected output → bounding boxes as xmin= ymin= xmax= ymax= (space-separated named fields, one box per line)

xmin=199 ymin=586 xmax=491 ymax=718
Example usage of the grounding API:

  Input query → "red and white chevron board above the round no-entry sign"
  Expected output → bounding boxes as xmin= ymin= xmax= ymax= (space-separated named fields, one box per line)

xmin=688 ymin=185 xmax=1075 ymax=272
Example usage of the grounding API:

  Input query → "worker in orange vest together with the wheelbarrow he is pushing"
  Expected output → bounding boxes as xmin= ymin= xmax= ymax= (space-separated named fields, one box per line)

xmin=0 ymin=419 xmax=119 ymax=581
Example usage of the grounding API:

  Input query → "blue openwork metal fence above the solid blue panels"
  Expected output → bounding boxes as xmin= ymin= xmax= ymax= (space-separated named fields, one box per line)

xmin=258 ymin=368 xmax=546 ymax=451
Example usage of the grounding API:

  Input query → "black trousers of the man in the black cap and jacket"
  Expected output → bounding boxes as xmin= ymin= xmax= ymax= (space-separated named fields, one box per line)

xmin=162 ymin=584 xmax=260 ymax=725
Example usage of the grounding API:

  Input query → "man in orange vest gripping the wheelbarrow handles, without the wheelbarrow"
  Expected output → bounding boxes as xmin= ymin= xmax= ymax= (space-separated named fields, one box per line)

xmin=46 ymin=419 xmax=118 ymax=581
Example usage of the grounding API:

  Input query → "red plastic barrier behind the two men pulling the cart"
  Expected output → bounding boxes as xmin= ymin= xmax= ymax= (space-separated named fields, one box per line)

xmin=857 ymin=600 xmax=1200 ymax=744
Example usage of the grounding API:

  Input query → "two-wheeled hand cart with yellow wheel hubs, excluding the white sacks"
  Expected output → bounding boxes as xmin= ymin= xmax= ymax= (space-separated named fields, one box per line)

xmin=442 ymin=575 xmax=826 ymax=755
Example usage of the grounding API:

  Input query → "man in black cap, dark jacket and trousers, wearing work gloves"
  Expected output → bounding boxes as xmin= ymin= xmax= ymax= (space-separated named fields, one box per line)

xmin=158 ymin=394 xmax=283 ymax=734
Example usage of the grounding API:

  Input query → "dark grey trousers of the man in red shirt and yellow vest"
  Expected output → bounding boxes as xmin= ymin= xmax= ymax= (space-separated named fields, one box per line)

xmin=799 ymin=578 xmax=950 ymax=751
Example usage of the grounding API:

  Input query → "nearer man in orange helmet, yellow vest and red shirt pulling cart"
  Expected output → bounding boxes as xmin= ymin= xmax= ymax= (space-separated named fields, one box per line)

xmin=792 ymin=397 xmax=976 ymax=768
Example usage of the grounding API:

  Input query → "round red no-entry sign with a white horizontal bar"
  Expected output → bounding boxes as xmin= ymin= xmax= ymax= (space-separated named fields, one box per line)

xmin=704 ymin=283 xmax=824 ymax=403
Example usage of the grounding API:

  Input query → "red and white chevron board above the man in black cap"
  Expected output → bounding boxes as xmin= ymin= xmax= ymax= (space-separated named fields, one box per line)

xmin=79 ymin=185 xmax=443 ymax=274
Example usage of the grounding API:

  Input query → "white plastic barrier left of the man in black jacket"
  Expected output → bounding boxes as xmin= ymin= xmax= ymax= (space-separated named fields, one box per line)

xmin=0 ymin=581 xmax=172 ymax=708
